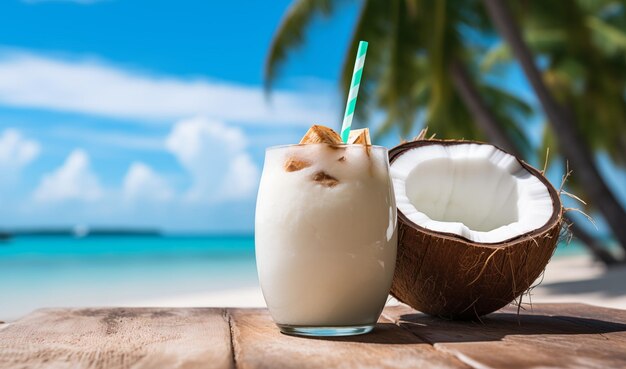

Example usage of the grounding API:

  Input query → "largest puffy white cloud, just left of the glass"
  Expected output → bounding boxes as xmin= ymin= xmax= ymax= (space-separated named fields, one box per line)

xmin=166 ymin=117 xmax=260 ymax=201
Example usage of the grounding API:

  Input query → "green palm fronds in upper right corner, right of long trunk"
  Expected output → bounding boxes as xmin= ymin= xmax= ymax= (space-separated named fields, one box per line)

xmin=503 ymin=0 xmax=626 ymax=165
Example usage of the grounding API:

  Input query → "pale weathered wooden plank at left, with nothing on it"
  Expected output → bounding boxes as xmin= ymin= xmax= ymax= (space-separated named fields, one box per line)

xmin=0 ymin=308 xmax=234 ymax=369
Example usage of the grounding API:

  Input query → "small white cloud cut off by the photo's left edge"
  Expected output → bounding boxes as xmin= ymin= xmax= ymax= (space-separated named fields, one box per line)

xmin=0 ymin=128 xmax=41 ymax=170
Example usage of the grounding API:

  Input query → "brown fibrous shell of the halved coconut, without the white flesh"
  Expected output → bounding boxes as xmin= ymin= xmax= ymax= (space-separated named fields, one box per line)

xmin=389 ymin=140 xmax=562 ymax=319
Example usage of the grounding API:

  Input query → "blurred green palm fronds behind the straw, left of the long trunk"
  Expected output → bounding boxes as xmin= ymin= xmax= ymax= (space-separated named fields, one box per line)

xmin=265 ymin=0 xmax=624 ymax=257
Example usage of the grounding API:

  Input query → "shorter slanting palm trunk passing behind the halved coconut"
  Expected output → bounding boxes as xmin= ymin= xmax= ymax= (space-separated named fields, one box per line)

xmin=450 ymin=60 xmax=619 ymax=266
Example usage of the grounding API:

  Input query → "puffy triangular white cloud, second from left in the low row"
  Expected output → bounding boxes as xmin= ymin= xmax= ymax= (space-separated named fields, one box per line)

xmin=33 ymin=149 xmax=103 ymax=202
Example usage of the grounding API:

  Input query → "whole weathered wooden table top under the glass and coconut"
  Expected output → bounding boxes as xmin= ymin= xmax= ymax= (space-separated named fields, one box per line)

xmin=0 ymin=304 xmax=626 ymax=369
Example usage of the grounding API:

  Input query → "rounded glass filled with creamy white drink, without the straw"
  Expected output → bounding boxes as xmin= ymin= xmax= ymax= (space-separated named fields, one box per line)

xmin=255 ymin=143 xmax=397 ymax=334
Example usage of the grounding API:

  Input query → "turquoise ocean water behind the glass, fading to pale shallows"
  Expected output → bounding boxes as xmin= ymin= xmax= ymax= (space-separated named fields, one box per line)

xmin=0 ymin=235 xmax=584 ymax=320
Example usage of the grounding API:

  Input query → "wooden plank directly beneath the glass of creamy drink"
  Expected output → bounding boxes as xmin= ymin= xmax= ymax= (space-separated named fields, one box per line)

xmin=229 ymin=309 xmax=467 ymax=369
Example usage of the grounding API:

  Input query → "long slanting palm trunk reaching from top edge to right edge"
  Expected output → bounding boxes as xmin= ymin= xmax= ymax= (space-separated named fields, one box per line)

xmin=483 ymin=0 xmax=626 ymax=250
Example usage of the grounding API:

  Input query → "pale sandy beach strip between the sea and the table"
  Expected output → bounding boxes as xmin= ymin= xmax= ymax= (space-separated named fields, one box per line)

xmin=125 ymin=255 xmax=626 ymax=309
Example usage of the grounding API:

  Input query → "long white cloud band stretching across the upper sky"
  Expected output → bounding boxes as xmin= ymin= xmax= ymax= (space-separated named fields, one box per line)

xmin=0 ymin=49 xmax=338 ymax=126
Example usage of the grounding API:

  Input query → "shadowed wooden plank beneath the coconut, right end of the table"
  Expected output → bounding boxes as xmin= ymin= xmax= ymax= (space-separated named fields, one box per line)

xmin=385 ymin=305 xmax=626 ymax=369
